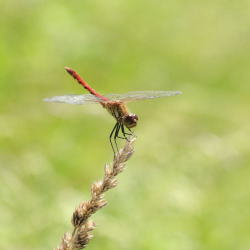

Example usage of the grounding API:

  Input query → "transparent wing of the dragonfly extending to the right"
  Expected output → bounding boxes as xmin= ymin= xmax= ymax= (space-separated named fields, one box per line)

xmin=104 ymin=90 xmax=182 ymax=102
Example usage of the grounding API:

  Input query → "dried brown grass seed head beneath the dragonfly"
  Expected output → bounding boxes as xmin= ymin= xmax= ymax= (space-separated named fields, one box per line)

xmin=56 ymin=137 xmax=135 ymax=250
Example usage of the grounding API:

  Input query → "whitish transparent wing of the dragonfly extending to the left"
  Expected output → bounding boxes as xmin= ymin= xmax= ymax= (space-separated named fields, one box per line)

xmin=44 ymin=94 xmax=102 ymax=104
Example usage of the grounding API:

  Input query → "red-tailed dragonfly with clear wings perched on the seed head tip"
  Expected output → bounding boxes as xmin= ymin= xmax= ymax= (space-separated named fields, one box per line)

xmin=44 ymin=67 xmax=181 ymax=156
